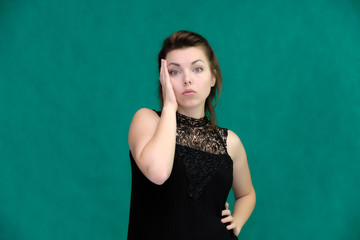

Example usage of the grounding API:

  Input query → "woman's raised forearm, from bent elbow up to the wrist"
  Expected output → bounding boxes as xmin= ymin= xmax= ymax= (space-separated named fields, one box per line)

xmin=140 ymin=107 xmax=176 ymax=184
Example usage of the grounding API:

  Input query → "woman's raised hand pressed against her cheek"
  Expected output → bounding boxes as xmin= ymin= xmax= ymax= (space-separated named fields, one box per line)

xmin=160 ymin=59 xmax=178 ymax=111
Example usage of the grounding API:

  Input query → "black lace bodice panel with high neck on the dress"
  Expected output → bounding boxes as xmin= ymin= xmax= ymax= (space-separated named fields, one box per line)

xmin=175 ymin=112 xmax=232 ymax=199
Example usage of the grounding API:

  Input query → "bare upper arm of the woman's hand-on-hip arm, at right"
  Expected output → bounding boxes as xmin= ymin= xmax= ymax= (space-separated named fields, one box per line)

xmin=227 ymin=130 xmax=254 ymax=198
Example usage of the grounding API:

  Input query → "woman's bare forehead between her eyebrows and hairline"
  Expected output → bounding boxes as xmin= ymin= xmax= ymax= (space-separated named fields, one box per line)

xmin=166 ymin=47 xmax=208 ymax=64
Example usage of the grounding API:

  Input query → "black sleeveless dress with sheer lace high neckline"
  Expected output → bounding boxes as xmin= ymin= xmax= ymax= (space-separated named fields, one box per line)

xmin=128 ymin=109 xmax=237 ymax=240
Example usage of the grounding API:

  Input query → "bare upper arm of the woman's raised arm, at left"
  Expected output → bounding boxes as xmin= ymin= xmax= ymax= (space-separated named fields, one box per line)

xmin=128 ymin=108 xmax=159 ymax=165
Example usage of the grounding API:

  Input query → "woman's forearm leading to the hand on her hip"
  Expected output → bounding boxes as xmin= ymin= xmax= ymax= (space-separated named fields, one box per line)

xmin=233 ymin=189 xmax=256 ymax=229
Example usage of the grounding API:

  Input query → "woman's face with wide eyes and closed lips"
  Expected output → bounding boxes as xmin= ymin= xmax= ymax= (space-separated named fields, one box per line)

xmin=166 ymin=47 xmax=216 ymax=112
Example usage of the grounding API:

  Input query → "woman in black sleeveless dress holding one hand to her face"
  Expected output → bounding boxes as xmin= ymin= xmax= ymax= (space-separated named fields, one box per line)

xmin=128 ymin=31 xmax=255 ymax=240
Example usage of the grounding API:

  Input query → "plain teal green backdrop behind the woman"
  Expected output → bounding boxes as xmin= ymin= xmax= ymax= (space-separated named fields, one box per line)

xmin=0 ymin=0 xmax=360 ymax=240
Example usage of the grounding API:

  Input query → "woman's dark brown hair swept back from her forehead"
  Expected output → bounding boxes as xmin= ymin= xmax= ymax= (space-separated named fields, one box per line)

xmin=158 ymin=30 xmax=222 ymax=127
